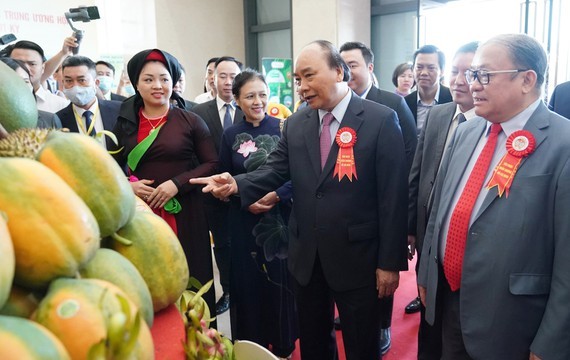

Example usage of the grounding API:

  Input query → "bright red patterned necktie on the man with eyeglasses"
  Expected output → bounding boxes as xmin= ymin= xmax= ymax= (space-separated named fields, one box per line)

xmin=443 ymin=124 xmax=502 ymax=291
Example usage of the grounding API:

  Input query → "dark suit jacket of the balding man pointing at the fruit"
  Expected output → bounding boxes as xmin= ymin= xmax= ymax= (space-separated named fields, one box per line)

xmin=236 ymin=94 xmax=407 ymax=291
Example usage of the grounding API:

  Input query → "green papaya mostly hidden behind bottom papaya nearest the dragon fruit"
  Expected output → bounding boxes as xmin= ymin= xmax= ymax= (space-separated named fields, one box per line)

xmin=79 ymin=248 xmax=154 ymax=326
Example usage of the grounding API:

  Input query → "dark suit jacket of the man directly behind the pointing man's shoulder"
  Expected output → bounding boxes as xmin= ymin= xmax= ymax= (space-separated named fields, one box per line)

xmin=366 ymin=86 xmax=418 ymax=172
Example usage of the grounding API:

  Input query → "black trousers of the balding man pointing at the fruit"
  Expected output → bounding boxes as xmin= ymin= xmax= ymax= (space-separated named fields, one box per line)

xmin=293 ymin=256 xmax=380 ymax=360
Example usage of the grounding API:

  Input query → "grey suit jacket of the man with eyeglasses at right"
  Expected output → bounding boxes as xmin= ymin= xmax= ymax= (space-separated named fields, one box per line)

xmin=418 ymin=103 xmax=570 ymax=360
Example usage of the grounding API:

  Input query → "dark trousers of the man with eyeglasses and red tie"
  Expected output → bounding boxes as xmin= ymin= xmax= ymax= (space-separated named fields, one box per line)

xmin=436 ymin=266 xmax=472 ymax=360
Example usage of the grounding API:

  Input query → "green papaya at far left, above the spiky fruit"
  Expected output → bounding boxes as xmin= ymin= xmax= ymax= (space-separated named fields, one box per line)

xmin=0 ymin=62 xmax=38 ymax=132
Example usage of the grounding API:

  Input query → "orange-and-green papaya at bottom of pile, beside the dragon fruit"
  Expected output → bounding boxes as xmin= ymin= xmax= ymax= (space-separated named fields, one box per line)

xmin=34 ymin=278 xmax=154 ymax=360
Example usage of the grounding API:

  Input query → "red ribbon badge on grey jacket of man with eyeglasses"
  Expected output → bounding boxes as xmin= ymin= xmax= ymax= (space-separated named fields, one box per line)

xmin=487 ymin=130 xmax=536 ymax=197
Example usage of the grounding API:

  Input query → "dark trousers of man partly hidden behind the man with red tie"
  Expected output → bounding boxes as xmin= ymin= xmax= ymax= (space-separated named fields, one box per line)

xmin=416 ymin=252 xmax=447 ymax=360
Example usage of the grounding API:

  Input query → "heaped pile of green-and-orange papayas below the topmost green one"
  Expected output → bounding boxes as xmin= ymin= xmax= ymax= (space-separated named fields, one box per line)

xmin=0 ymin=128 xmax=202 ymax=359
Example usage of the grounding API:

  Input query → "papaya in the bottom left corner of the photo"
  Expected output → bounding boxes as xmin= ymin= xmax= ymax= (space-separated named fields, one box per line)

xmin=0 ymin=315 xmax=70 ymax=360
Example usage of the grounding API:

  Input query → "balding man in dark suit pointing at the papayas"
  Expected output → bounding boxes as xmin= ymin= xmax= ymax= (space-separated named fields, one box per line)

xmin=191 ymin=40 xmax=407 ymax=360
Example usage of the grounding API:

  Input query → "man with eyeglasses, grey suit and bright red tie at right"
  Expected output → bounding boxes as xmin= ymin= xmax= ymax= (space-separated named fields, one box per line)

xmin=418 ymin=34 xmax=570 ymax=360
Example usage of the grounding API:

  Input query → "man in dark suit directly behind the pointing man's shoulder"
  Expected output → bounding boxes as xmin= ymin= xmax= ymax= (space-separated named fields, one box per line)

xmin=335 ymin=42 xmax=418 ymax=354
